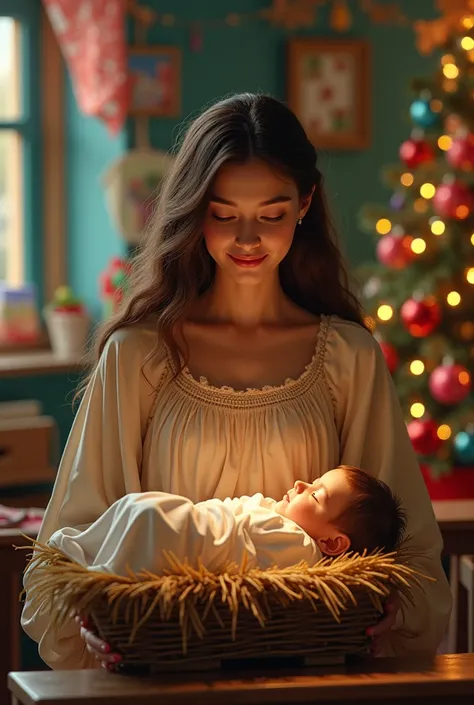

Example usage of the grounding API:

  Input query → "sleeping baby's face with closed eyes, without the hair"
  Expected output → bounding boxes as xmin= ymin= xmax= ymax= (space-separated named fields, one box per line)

xmin=275 ymin=468 xmax=351 ymax=555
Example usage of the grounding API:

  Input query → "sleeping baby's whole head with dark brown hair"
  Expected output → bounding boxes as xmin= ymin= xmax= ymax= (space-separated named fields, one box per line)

xmin=275 ymin=465 xmax=406 ymax=556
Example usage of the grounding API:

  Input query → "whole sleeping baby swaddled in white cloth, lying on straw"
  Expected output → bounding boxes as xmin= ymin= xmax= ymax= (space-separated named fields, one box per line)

xmin=48 ymin=466 xmax=406 ymax=575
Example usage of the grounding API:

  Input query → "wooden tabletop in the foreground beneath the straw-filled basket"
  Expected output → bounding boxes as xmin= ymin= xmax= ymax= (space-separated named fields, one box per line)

xmin=8 ymin=654 xmax=474 ymax=705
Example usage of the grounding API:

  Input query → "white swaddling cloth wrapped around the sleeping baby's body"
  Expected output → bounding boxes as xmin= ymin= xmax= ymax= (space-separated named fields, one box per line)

xmin=48 ymin=492 xmax=321 ymax=575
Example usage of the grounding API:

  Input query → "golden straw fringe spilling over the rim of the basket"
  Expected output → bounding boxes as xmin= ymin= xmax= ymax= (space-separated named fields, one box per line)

xmin=17 ymin=537 xmax=433 ymax=636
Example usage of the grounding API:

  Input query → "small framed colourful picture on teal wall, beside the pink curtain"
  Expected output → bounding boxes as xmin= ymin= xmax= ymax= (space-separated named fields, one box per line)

xmin=128 ymin=46 xmax=181 ymax=117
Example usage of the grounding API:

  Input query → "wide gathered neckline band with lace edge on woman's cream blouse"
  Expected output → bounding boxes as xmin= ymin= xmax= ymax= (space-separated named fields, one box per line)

xmin=168 ymin=315 xmax=330 ymax=406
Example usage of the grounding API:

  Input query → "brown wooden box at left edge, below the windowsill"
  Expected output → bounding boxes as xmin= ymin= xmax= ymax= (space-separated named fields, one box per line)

xmin=0 ymin=416 xmax=58 ymax=488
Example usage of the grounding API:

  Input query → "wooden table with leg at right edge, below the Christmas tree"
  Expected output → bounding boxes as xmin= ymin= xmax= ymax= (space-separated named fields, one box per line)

xmin=433 ymin=499 xmax=474 ymax=653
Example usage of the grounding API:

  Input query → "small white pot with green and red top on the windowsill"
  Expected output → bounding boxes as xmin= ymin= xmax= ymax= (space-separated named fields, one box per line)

xmin=45 ymin=286 xmax=90 ymax=357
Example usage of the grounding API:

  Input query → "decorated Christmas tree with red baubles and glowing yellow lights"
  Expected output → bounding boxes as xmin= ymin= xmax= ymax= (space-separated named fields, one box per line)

xmin=360 ymin=12 xmax=474 ymax=476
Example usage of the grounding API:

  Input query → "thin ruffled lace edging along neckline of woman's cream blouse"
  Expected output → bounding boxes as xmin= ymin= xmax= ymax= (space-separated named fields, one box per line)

xmin=172 ymin=314 xmax=330 ymax=397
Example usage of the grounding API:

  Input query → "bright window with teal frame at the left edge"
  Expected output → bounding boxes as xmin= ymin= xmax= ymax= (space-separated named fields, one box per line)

xmin=0 ymin=0 xmax=43 ymax=288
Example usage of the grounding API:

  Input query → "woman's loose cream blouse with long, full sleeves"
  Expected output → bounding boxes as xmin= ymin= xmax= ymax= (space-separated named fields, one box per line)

xmin=22 ymin=317 xmax=451 ymax=668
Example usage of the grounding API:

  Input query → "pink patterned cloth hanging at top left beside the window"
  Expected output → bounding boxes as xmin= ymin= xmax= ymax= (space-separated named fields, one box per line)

xmin=43 ymin=0 xmax=130 ymax=134
